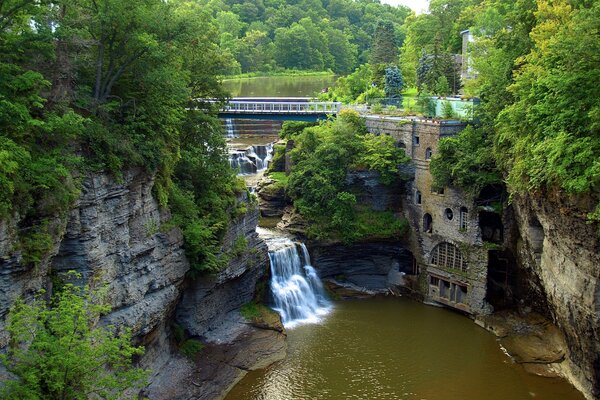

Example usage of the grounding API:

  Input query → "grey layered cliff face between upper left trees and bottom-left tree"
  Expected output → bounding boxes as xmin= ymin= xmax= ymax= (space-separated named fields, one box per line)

xmin=0 ymin=169 xmax=189 ymax=369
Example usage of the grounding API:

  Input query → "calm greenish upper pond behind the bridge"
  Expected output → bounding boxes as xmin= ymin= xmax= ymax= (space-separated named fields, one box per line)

xmin=223 ymin=75 xmax=337 ymax=97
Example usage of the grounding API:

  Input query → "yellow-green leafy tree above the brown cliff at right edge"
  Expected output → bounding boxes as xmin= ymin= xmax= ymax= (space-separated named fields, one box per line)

xmin=496 ymin=1 xmax=600 ymax=198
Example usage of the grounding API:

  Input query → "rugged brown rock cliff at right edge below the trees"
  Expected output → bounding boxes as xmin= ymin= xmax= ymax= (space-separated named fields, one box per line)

xmin=512 ymin=194 xmax=600 ymax=398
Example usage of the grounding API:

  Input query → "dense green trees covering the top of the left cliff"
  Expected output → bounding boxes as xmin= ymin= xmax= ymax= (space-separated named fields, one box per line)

xmin=0 ymin=0 xmax=241 ymax=269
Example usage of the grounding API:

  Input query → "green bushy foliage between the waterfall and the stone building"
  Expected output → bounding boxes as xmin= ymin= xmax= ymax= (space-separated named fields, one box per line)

xmin=287 ymin=111 xmax=407 ymax=242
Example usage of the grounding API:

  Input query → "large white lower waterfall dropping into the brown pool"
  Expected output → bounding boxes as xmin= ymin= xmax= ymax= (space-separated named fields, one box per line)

xmin=267 ymin=238 xmax=331 ymax=328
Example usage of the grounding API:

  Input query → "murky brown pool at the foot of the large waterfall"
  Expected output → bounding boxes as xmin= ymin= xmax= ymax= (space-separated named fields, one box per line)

xmin=226 ymin=298 xmax=583 ymax=400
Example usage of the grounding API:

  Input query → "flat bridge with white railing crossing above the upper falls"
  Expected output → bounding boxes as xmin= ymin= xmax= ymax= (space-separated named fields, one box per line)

xmin=219 ymin=97 xmax=342 ymax=121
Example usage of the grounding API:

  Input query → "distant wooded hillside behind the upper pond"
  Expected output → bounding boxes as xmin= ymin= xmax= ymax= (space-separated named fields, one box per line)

xmin=202 ymin=0 xmax=410 ymax=74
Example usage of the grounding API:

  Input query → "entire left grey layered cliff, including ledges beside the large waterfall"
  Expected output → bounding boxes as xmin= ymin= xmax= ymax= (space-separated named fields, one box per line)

xmin=0 ymin=169 xmax=285 ymax=399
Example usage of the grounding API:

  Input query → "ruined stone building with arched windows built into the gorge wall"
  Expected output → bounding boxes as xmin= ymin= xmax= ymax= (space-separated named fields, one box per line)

xmin=366 ymin=116 xmax=492 ymax=314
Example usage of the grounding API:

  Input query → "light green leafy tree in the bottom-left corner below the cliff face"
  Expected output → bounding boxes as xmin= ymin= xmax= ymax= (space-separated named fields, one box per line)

xmin=0 ymin=283 xmax=147 ymax=400
